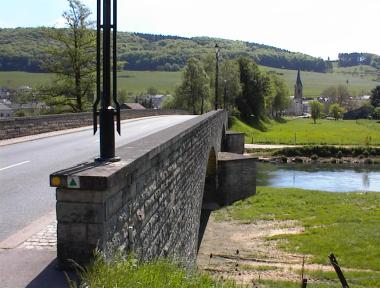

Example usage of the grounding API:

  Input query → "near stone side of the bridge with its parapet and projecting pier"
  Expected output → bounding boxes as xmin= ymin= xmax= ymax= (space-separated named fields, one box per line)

xmin=50 ymin=110 xmax=255 ymax=267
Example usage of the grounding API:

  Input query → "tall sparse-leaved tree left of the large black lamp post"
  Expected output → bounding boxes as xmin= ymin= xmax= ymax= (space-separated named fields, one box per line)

xmin=43 ymin=0 xmax=96 ymax=112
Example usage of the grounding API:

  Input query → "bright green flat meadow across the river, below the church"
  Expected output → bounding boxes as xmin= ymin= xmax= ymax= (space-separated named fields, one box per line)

xmin=231 ymin=117 xmax=380 ymax=145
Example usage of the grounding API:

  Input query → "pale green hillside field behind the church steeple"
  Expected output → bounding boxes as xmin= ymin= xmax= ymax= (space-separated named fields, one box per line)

xmin=261 ymin=66 xmax=380 ymax=98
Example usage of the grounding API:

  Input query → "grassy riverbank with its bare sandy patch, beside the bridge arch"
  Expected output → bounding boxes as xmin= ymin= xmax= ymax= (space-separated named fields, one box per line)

xmin=210 ymin=187 xmax=380 ymax=287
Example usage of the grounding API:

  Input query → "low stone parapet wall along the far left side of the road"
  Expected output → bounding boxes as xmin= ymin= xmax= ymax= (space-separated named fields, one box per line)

xmin=0 ymin=109 xmax=188 ymax=140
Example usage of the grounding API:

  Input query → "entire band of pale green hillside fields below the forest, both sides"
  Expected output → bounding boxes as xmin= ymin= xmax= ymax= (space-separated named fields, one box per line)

xmin=0 ymin=66 xmax=380 ymax=97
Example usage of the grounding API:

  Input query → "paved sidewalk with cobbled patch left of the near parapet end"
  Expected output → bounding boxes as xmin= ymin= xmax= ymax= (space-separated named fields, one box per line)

xmin=0 ymin=213 xmax=75 ymax=288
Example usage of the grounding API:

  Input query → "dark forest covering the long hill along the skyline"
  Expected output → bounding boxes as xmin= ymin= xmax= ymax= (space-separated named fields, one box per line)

xmin=0 ymin=28 xmax=336 ymax=72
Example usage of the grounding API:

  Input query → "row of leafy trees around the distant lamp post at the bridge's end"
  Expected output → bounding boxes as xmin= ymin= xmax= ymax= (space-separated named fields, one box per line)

xmin=165 ymin=54 xmax=289 ymax=121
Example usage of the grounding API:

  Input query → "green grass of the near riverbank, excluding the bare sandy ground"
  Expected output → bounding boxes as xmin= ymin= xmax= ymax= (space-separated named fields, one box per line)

xmin=216 ymin=187 xmax=380 ymax=287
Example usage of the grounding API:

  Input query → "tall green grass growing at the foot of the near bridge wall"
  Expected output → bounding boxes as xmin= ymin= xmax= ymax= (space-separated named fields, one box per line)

xmin=74 ymin=255 xmax=245 ymax=288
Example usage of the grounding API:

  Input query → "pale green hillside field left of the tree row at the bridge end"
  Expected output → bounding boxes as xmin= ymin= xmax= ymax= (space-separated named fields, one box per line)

xmin=0 ymin=71 xmax=181 ymax=94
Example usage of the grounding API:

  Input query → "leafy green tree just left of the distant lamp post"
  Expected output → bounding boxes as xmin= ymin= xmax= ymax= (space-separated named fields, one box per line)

xmin=171 ymin=58 xmax=211 ymax=114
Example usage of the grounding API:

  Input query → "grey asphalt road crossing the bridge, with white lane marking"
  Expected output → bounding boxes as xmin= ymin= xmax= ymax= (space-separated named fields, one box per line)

xmin=0 ymin=115 xmax=194 ymax=241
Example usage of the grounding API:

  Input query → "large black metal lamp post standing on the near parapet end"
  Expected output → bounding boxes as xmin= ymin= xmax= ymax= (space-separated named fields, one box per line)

xmin=93 ymin=0 xmax=120 ymax=161
